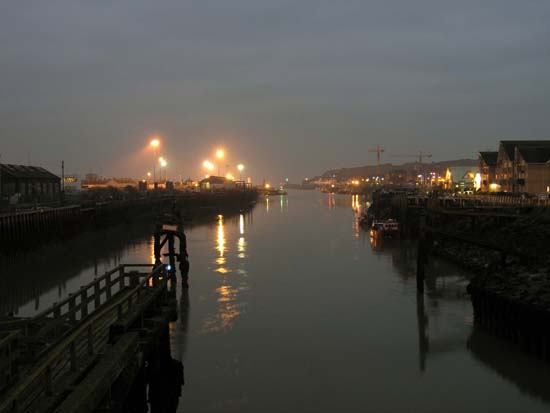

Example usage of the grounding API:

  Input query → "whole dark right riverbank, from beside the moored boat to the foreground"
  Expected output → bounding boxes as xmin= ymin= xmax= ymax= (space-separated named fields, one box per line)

xmin=371 ymin=190 xmax=550 ymax=359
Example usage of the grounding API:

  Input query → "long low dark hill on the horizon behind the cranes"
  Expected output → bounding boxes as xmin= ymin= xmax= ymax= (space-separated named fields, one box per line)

xmin=320 ymin=159 xmax=478 ymax=179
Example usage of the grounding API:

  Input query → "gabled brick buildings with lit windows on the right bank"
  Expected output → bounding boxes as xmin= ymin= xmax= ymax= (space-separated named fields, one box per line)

xmin=479 ymin=140 xmax=550 ymax=194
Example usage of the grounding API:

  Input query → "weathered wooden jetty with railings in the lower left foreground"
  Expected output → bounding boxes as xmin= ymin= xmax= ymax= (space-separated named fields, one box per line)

xmin=0 ymin=264 xmax=181 ymax=413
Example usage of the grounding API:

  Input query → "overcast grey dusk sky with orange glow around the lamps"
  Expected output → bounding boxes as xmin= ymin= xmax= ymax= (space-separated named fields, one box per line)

xmin=0 ymin=0 xmax=550 ymax=181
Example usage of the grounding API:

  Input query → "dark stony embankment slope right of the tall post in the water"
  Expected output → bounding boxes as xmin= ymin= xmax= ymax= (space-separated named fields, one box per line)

xmin=432 ymin=210 xmax=550 ymax=360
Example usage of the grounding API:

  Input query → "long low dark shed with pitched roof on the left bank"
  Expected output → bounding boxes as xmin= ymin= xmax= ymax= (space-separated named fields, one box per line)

xmin=0 ymin=164 xmax=61 ymax=204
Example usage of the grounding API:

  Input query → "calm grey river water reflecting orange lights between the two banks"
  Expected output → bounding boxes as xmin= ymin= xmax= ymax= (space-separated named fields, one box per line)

xmin=0 ymin=192 xmax=550 ymax=412
